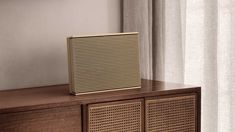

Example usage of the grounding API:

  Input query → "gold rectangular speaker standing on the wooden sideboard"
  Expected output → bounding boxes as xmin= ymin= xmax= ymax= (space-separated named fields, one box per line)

xmin=68 ymin=33 xmax=141 ymax=95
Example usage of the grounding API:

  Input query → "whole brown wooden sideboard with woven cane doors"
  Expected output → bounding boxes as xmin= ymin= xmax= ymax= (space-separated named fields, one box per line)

xmin=0 ymin=80 xmax=201 ymax=132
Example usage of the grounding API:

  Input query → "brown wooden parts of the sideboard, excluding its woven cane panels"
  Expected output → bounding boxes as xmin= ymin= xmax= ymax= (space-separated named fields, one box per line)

xmin=0 ymin=79 xmax=201 ymax=132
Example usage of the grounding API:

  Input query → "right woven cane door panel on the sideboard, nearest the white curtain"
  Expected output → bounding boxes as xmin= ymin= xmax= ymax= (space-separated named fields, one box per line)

xmin=146 ymin=95 xmax=196 ymax=132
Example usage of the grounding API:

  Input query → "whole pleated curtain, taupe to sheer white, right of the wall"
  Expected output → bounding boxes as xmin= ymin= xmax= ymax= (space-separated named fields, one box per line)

xmin=122 ymin=0 xmax=235 ymax=132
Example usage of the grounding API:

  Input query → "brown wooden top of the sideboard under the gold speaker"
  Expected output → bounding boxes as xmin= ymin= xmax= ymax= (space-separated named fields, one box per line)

xmin=0 ymin=79 xmax=200 ymax=113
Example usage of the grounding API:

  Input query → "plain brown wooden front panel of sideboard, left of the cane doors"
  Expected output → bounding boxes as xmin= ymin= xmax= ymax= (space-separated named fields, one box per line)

xmin=0 ymin=105 xmax=81 ymax=132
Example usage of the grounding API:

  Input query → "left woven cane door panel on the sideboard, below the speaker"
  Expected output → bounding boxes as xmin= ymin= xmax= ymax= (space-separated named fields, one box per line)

xmin=88 ymin=100 xmax=143 ymax=132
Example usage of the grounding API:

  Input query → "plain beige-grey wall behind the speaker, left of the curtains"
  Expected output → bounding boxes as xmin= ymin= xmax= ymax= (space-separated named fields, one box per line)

xmin=0 ymin=0 xmax=120 ymax=90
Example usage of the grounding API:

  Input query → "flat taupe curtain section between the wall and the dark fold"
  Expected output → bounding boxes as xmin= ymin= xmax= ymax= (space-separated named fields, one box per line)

xmin=123 ymin=0 xmax=153 ymax=79
